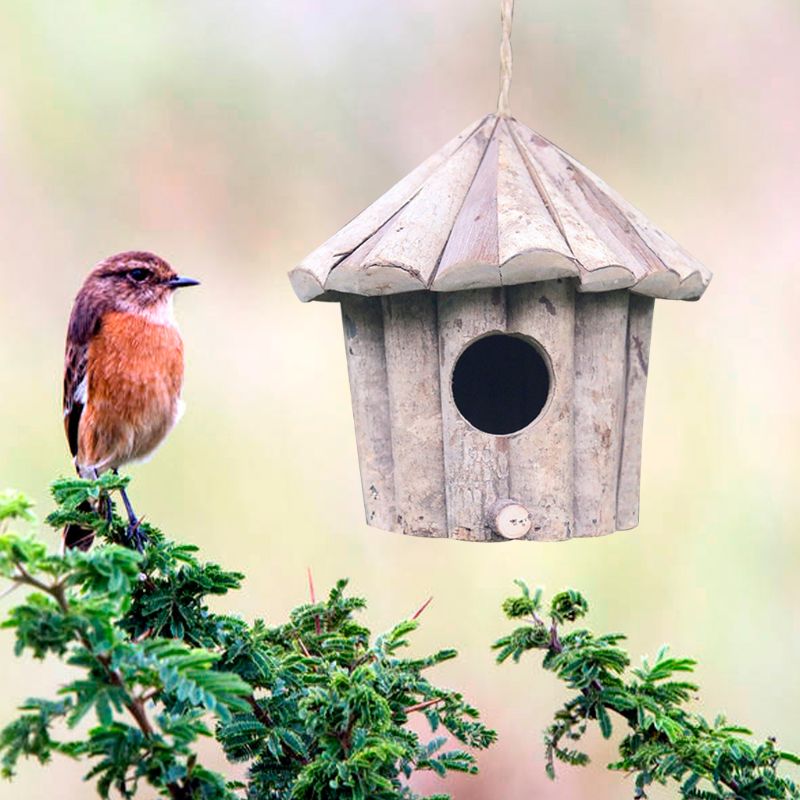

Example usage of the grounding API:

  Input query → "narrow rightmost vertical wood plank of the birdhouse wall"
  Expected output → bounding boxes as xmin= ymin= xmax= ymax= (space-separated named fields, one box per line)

xmin=616 ymin=294 xmax=655 ymax=530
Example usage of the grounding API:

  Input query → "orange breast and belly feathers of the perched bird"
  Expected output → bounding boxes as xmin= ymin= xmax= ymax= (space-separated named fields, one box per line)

xmin=77 ymin=312 xmax=183 ymax=471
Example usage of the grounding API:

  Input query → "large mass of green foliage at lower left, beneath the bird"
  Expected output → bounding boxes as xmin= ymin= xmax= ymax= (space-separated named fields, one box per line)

xmin=0 ymin=474 xmax=495 ymax=800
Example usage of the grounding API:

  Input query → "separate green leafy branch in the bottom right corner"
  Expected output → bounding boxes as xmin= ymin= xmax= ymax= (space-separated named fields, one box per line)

xmin=494 ymin=581 xmax=800 ymax=800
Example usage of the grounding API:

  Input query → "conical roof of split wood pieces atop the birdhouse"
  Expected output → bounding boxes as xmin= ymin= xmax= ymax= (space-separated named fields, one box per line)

xmin=289 ymin=114 xmax=711 ymax=301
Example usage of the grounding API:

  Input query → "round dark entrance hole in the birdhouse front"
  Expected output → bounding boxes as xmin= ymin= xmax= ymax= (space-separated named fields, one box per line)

xmin=453 ymin=333 xmax=550 ymax=436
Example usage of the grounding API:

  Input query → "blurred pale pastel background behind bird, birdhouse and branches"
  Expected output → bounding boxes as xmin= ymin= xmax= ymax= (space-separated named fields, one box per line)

xmin=0 ymin=0 xmax=800 ymax=800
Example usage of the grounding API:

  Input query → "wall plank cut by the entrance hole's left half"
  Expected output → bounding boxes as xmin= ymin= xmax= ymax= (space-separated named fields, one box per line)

xmin=438 ymin=289 xmax=509 ymax=541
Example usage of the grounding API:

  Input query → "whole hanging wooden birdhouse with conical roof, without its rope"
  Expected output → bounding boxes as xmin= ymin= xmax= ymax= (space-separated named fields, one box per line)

xmin=290 ymin=114 xmax=711 ymax=541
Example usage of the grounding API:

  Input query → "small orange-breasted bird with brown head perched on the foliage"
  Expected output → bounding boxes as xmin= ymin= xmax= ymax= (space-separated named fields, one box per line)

xmin=63 ymin=250 xmax=200 ymax=552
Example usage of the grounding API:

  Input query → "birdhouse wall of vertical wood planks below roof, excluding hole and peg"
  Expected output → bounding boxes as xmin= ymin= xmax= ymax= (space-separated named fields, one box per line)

xmin=342 ymin=280 xmax=653 ymax=541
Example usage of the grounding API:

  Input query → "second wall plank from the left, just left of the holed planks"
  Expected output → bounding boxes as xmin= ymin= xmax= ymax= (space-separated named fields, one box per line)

xmin=383 ymin=292 xmax=447 ymax=537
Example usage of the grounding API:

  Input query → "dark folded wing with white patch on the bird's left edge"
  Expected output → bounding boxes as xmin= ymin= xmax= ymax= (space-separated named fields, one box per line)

xmin=63 ymin=293 xmax=103 ymax=456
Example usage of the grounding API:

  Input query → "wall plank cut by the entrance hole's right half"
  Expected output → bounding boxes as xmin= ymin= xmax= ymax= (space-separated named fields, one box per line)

xmin=506 ymin=280 xmax=575 ymax=541
